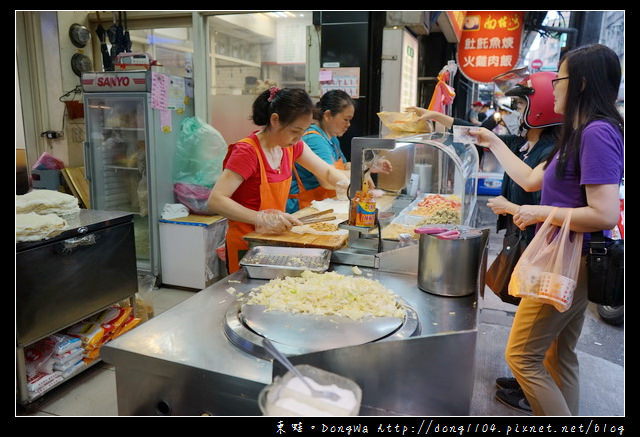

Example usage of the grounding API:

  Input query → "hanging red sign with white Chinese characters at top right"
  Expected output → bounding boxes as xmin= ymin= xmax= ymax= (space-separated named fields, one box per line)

xmin=458 ymin=11 xmax=524 ymax=83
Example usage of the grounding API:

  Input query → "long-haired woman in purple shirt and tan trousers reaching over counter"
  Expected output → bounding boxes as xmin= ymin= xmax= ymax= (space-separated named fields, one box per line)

xmin=471 ymin=44 xmax=624 ymax=416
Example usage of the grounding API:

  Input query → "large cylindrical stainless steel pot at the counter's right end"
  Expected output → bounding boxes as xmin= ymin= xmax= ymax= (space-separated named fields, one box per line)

xmin=418 ymin=225 xmax=490 ymax=296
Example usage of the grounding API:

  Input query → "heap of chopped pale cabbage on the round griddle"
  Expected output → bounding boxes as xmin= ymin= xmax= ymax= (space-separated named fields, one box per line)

xmin=246 ymin=271 xmax=404 ymax=320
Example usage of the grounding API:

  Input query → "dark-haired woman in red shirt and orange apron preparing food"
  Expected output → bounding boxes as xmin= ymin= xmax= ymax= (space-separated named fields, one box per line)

xmin=207 ymin=87 xmax=349 ymax=273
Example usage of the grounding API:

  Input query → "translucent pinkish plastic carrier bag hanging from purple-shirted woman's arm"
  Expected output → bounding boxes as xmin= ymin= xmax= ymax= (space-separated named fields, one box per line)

xmin=509 ymin=208 xmax=583 ymax=312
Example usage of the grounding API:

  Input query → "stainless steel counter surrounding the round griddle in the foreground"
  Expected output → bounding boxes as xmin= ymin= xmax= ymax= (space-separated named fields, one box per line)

xmin=101 ymin=265 xmax=477 ymax=415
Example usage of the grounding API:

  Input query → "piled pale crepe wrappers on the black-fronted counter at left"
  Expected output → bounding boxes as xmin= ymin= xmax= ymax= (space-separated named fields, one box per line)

xmin=16 ymin=190 xmax=80 ymax=242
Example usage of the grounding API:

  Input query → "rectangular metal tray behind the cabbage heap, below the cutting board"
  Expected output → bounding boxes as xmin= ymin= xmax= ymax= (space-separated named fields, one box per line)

xmin=240 ymin=246 xmax=331 ymax=279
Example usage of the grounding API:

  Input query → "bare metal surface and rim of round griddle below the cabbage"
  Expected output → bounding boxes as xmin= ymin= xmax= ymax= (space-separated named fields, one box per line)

xmin=224 ymin=299 xmax=419 ymax=359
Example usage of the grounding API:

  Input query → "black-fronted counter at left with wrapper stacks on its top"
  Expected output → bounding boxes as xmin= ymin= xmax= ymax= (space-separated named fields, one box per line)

xmin=15 ymin=209 xmax=138 ymax=404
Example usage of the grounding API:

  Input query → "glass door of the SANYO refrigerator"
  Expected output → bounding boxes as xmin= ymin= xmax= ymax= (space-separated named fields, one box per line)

xmin=85 ymin=93 xmax=151 ymax=269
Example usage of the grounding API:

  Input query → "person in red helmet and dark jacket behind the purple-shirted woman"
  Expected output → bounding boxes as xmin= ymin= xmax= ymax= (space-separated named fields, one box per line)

xmin=407 ymin=68 xmax=563 ymax=414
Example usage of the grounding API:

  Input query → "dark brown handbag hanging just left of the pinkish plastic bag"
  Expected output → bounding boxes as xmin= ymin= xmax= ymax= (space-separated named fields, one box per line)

xmin=485 ymin=230 xmax=527 ymax=305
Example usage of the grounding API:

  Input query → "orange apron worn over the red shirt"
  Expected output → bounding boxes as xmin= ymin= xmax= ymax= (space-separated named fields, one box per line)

xmin=226 ymin=138 xmax=293 ymax=274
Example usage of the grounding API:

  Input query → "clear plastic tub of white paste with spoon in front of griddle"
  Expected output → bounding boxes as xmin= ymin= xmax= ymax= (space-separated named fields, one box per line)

xmin=258 ymin=364 xmax=362 ymax=416
